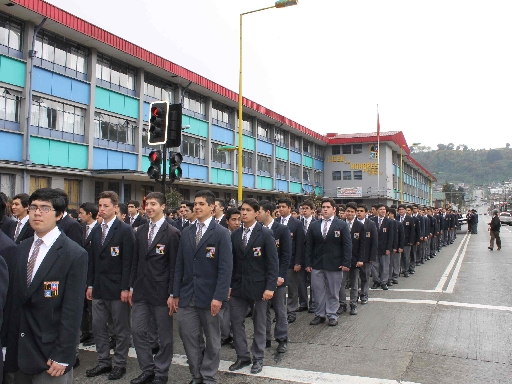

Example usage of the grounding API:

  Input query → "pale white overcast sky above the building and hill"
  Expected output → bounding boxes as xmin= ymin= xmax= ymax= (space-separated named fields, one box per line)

xmin=48 ymin=0 xmax=512 ymax=149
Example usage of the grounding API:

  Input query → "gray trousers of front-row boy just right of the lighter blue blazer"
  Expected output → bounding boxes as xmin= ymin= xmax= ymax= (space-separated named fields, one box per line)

xmin=230 ymin=296 xmax=268 ymax=361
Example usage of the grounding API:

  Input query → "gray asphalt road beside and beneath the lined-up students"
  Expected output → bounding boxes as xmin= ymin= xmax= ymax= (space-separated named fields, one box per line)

xmin=74 ymin=212 xmax=512 ymax=384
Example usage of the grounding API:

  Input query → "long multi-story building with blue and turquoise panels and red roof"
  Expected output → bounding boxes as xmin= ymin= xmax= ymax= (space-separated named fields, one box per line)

xmin=0 ymin=0 xmax=431 ymax=207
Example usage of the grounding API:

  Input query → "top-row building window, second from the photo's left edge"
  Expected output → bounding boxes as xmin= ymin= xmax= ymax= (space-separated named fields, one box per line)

xmin=36 ymin=31 xmax=88 ymax=73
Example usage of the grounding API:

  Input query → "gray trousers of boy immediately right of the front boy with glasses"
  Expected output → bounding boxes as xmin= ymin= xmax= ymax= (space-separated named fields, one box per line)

xmin=92 ymin=299 xmax=130 ymax=367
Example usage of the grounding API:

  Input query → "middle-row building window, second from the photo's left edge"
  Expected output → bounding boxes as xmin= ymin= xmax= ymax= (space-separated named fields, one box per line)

xmin=30 ymin=96 xmax=85 ymax=135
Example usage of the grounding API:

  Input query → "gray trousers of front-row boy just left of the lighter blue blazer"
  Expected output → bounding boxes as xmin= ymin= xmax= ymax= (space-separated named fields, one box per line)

xmin=132 ymin=301 xmax=173 ymax=377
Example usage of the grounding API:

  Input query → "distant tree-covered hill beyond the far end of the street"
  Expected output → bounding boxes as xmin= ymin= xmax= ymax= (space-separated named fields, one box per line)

xmin=411 ymin=147 xmax=512 ymax=185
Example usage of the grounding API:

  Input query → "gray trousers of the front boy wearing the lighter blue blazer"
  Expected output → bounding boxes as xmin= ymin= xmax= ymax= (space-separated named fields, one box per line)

xmin=178 ymin=304 xmax=222 ymax=383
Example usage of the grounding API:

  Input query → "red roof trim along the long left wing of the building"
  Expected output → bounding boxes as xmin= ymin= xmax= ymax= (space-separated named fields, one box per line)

xmin=11 ymin=0 xmax=328 ymax=143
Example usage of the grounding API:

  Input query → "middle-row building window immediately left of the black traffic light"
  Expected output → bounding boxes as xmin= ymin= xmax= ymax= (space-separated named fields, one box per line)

xmin=94 ymin=112 xmax=137 ymax=145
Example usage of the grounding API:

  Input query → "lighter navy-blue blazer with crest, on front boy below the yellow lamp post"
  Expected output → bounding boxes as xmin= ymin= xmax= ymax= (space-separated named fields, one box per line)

xmin=173 ymin=219 xmax=233 ymax=308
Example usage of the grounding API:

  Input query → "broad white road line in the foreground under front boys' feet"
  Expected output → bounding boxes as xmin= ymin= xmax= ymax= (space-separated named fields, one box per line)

xmin=80 ymin=344 xmax=418 ymax=384
